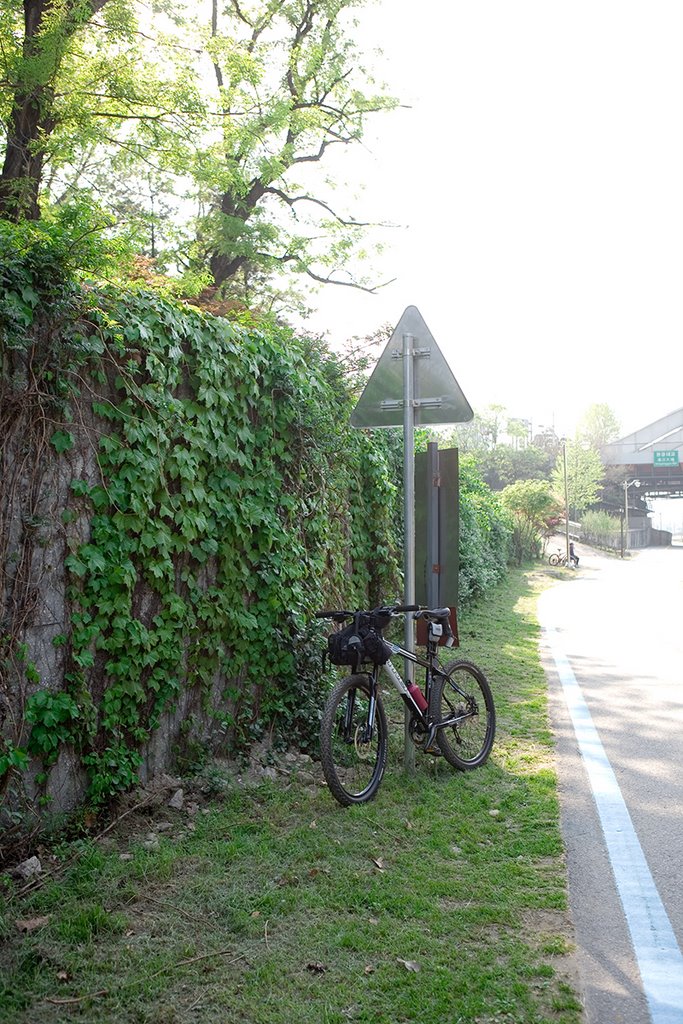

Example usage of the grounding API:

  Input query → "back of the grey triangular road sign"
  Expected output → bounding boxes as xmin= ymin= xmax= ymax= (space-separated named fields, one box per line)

xmin=351 ymin=306 xmax=474 ymax=427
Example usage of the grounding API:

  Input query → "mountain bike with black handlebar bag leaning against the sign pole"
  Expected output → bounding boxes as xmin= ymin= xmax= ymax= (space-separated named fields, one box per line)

xmin=316 ymin=605 xmax=496 ymax=806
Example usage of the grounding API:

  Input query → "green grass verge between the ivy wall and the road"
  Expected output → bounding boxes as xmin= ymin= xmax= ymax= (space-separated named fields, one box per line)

xmin=0 ymin=572 xmax=582 ymax=1024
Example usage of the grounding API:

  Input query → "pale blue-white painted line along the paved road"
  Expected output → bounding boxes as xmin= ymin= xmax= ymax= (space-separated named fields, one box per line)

xmin=544 ymin=628 xmax=683 ymax=1024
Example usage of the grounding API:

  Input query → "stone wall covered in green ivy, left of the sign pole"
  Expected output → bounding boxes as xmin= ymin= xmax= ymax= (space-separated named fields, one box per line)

xmin=0 ymin=237 xmax=400 ymax=809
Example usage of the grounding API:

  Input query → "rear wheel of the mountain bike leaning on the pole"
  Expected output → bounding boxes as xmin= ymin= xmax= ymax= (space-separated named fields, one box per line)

xmin=429 ymin=659 xmax=496 ymax=771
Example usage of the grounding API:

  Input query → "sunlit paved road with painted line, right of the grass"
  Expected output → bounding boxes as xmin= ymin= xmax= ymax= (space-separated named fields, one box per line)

xmin=540 ymin=545 xmax=683 ymax=1024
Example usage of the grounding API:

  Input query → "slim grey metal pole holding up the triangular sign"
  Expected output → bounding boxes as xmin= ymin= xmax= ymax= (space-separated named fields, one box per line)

xmin=403 ymin=334 xmax=415 ymax=772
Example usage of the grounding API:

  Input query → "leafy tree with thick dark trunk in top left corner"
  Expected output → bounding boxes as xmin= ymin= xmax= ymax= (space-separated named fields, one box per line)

xmin=0 ymin=0 xmax=202 ymax=220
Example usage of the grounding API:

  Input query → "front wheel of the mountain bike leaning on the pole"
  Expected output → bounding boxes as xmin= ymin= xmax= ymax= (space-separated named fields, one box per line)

xmin=321 ymin=675 xmax=387 ymax=807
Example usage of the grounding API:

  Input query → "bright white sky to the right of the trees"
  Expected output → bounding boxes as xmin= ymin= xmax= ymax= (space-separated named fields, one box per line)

xmin=309 ymin=0 xmax=683 ymax=434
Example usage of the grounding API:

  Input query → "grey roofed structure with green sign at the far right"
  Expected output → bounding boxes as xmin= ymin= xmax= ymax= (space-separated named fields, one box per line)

xmin=601 ymin=409 xmax=683 ymax=497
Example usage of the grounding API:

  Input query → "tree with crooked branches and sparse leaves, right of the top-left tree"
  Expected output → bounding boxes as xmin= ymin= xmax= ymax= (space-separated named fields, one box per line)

xmin=195 ymin=0 xmax=394 ymax=296
